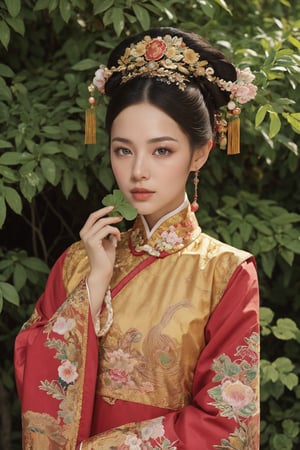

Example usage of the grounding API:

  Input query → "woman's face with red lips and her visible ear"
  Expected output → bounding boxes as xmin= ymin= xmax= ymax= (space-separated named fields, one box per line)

xmin=110 ymin=103 xmax=210 ymax=228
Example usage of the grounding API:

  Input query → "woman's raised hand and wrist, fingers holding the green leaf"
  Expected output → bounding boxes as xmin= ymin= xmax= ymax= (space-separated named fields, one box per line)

xmin=79 ymin=206 xmax=123 ymax=319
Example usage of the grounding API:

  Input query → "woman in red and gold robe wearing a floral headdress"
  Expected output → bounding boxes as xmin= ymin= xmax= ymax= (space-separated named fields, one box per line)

xmin=15 ymin=28 xmax=259 ymax=450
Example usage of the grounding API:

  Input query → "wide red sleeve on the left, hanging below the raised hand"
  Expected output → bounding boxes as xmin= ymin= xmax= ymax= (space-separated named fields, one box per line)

xmin=15 ymin=248 xmax=98 ymax=450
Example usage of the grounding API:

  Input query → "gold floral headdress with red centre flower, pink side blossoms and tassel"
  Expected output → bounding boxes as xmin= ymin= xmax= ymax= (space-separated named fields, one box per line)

xmin=84 ymin=34 xmax=257 ymax=154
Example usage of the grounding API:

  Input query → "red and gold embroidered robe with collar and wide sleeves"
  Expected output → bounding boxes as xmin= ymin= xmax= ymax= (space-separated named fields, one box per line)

xmin=15 ymin=207 xmax=259 ymax=450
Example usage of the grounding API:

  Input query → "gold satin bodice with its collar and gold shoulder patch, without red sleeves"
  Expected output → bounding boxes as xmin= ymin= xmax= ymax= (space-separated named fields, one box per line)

xmin=64 ymin=208 xmax=250 ymax=410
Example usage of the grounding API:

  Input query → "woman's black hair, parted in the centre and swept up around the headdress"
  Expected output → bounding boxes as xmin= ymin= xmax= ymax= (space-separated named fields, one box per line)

xmin=105 ymin=27 xmax=236 ymax=149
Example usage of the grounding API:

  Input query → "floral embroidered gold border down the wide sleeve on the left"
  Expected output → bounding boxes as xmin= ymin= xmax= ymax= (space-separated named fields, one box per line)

xmin=22 ymin=281 xmax=89 ymax=449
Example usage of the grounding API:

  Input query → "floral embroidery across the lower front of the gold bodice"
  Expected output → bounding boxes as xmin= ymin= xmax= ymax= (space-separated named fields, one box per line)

xmin=98 ymin=300 xmax=190 ymax=410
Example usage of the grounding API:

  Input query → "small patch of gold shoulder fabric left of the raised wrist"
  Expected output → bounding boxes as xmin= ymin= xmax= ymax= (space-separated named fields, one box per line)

xmin=62 ymin=241 xmax=89 ymax=295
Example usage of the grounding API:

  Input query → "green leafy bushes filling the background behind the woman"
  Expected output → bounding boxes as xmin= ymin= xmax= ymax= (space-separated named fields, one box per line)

xmin=0 ymin=0 xmax=300 ymax=450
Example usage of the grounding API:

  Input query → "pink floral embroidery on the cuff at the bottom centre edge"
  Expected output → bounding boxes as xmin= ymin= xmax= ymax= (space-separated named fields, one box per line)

xmin=117 ymin=417 xmax=177 ymax=450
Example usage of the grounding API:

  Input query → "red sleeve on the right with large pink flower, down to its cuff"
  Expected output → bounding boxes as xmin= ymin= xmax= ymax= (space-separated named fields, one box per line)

xmin=82 ymin=258 xmax=259 ymax=450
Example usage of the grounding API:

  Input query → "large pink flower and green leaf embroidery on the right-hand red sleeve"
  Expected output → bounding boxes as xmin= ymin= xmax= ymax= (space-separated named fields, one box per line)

xmin=208 ymin=333 xmax=259 ymax=450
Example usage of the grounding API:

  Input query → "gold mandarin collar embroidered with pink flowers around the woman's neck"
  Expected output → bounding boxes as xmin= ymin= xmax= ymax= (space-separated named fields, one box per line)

xmin=129 ymin=200 xmax=201 ymax=258
